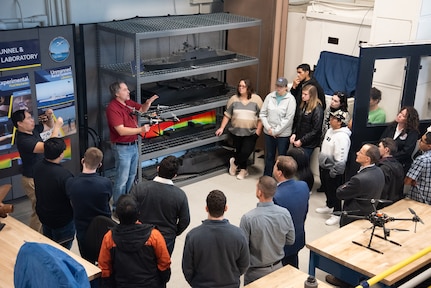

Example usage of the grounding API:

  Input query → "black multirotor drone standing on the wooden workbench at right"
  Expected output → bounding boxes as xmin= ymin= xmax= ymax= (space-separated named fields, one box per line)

xmin=340 ymin=198 xmax=424 ymax=254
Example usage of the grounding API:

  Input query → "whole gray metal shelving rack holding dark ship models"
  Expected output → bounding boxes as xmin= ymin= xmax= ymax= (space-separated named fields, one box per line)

xmin=97 ymin=13 xmax=262 ymax=183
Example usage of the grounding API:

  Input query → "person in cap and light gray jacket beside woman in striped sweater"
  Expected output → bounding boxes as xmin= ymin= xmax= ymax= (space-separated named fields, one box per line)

xmin=259 ymin=77 xmax=296 ymax=176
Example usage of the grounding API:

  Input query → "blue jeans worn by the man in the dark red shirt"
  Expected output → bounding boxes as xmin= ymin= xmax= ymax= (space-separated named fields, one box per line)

xmin=112 ymin=144 xmax=139 ymax=210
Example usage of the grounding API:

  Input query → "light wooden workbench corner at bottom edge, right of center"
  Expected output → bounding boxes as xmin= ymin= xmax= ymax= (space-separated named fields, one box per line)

xmin=244 ymin=265 xmax=332 ymax=288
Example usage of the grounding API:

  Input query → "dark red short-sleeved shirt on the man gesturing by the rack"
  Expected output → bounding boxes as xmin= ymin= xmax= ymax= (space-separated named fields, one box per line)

xmin=106 ymin=99 xmax=142 ymax=143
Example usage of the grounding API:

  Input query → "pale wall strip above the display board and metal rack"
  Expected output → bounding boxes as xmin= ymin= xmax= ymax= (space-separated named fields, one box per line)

xmin=0 ymin=0 xmax=216 ymax=30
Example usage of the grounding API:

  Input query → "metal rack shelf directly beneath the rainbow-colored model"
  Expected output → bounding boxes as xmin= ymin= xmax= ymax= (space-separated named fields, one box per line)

xmin=139 ymin=129 xmax=227 ymax=161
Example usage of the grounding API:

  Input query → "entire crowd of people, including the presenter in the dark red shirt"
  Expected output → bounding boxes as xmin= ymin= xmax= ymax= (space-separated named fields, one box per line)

xmin=6 ymin=64 xmax=431 ymax=287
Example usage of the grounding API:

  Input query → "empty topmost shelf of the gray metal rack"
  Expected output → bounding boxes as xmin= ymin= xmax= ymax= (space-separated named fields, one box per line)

xmin=98 ymin=13 xmax=262 ymax=40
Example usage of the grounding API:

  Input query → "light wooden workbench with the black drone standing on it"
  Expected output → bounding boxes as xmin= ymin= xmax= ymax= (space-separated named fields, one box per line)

xmin=306 ymin=199 xmax=431 ymax=286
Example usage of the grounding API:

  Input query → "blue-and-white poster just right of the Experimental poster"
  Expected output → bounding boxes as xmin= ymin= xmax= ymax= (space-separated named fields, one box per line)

xmin=34 ymin=66 xmax=76 ymax=137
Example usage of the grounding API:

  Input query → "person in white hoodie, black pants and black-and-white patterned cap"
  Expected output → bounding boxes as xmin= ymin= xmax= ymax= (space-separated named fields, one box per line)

xmin=316 ymin=110 xmax=352 ymax=225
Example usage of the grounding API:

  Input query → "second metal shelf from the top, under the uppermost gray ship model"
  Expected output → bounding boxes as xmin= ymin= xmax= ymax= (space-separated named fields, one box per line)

xmin=100 ymin=53 xmax=259 ymax=84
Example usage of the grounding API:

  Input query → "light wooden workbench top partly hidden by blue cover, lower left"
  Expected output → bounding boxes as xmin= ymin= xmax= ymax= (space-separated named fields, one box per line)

xmin=0 ymin=216 xmax=101 ymax=287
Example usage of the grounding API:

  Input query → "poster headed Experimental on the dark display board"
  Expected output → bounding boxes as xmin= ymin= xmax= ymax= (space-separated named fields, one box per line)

xmin=0 ymin=74 xmax=33 ymax=151
